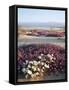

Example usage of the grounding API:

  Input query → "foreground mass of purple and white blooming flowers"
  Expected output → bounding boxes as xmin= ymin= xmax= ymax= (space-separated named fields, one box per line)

xmin=17 ymin=44 xmax=65 ymax=80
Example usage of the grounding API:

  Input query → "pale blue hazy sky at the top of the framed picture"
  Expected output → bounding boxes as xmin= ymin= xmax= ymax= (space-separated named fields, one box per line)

xmin=18 ymin=8 xmax=65 ymax=24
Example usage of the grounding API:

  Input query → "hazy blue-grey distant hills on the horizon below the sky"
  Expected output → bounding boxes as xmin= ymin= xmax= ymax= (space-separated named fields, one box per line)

xmin=18 ymin=22 xmax=65 ymax=28
